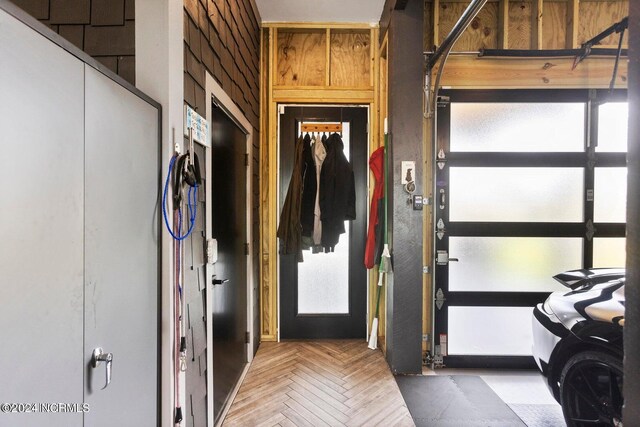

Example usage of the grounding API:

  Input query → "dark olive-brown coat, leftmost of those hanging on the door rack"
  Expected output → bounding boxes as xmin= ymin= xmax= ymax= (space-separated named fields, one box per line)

xmin=276 ymin=135 xmax=304 ymax=262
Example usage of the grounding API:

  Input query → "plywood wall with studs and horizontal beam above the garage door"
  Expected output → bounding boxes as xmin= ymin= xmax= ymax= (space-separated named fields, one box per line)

xmin=424 ymin=0 xmax=629 ymax=89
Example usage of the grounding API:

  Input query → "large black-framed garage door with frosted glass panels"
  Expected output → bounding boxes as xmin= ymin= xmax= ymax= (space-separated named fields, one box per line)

xmin=435 ymin=90 xmax=626 ymax=367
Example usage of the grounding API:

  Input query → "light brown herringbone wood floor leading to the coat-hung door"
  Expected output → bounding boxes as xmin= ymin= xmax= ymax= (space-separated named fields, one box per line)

xmin=223 ymin=340 xmax=414 ymax=427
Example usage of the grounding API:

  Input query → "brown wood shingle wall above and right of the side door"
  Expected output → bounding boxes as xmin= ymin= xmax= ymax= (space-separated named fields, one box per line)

xmin=181 ymin=0 xmax=261 ymax=348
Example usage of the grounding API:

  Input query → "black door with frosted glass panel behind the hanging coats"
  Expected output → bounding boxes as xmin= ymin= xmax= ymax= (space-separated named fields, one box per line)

xmin=279 ymin=107 xmax=368 ymax=339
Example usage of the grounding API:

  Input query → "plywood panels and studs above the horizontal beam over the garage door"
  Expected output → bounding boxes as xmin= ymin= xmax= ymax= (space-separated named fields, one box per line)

xmin=425 ymin=0 xmax=629 ymax=52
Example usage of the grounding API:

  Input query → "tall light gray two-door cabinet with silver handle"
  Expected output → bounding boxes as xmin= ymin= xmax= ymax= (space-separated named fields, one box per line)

xmin=0 ymin=5 xmax=159 ymax=426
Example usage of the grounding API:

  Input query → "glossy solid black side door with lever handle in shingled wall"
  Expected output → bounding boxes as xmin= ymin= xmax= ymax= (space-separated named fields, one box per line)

xmin=211 ymin=104 xmax=247 ymax=422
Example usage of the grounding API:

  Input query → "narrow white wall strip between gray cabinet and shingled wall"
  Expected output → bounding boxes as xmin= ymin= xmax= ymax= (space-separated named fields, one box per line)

xmin=135 ymin=0 xmax=186 ymax=427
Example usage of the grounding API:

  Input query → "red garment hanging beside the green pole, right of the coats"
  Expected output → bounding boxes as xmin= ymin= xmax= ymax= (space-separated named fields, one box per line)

xmin=364 ymin=147 xmax=384 ymax=268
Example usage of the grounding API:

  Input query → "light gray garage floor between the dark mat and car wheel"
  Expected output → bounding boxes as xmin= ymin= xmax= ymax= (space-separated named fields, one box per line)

xmin=422 ymin=368 xmax=566 ymax=427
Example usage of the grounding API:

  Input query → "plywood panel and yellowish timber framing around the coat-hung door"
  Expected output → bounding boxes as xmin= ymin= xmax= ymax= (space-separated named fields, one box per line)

xmin=260 ymin=23 xmax=380 ymax=341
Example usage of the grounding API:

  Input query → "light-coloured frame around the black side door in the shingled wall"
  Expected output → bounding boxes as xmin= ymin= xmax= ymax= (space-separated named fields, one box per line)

xmin=205 ymin=72 xmax=255 ymax=427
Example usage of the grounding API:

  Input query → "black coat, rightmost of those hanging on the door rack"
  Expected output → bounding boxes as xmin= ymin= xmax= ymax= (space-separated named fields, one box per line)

xmin=320 ymin=133 xmax=356 ymax=252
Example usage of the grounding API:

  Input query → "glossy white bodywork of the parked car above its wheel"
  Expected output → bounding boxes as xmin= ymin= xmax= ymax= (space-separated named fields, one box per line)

xmin=547 ymin=277 xmax=625 ymax=330
